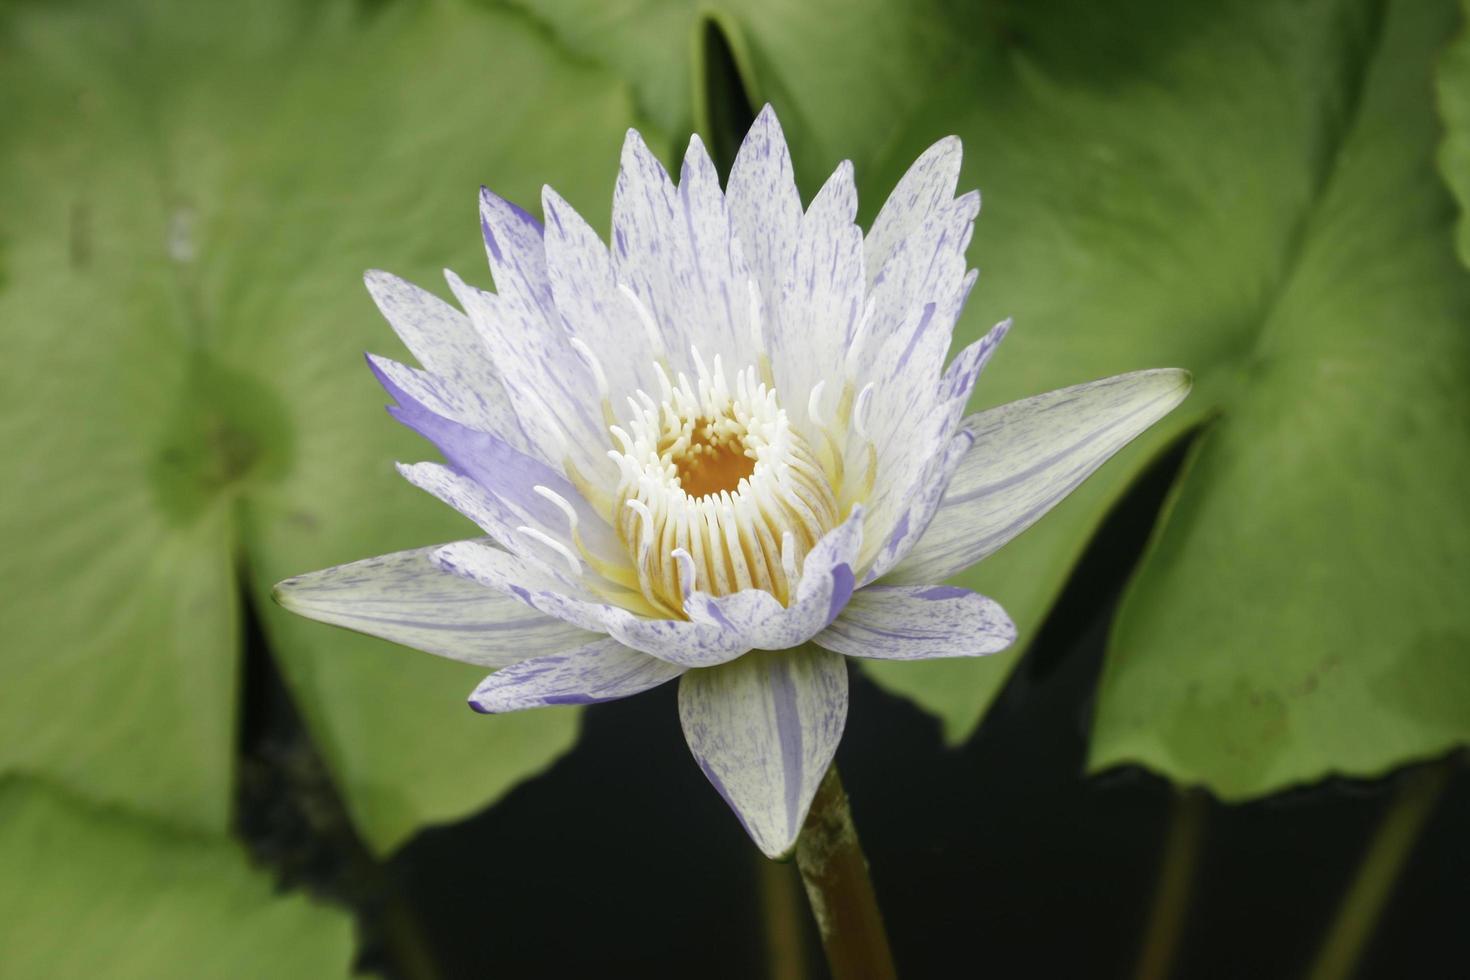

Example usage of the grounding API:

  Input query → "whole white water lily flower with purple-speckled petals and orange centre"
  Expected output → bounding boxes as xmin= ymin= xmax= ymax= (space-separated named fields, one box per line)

xmin=276 ymin=107 xmax=1189 ymax=857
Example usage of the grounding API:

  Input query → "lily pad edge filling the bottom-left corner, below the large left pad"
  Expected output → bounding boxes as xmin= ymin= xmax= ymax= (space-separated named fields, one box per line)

xmin=0 ymin=779 xmax=353 ymax=980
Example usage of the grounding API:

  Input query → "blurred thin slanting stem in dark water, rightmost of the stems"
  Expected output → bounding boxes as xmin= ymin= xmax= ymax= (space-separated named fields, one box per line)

xmin=1307 ymin=760 xmax=1454 ymax=980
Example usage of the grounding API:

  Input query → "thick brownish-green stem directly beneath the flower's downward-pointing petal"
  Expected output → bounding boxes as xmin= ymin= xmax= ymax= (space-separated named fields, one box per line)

xmin=797 ymin=763 xmax=897 ymax=980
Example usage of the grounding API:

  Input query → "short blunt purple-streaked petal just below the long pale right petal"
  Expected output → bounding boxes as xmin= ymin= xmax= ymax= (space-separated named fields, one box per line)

xmin=813 ymin=585 xmax=1016 ymax=660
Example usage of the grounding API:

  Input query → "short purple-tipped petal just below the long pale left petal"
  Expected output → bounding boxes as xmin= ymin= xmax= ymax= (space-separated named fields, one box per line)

xmin=469 ymin=636 xmax=685 ymax=714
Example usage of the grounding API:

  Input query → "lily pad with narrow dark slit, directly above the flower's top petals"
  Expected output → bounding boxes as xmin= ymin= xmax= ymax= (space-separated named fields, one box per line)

xmin=512 ymin=0 xmax=982 ymax=188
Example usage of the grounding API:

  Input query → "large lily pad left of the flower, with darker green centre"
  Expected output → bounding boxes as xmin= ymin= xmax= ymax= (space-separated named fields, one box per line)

xmin=0 ymin=0 xmax=655 ymax=849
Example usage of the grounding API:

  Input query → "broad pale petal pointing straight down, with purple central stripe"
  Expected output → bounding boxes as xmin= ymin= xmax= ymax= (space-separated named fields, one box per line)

xmin=679 ymin=645 xmax=847 ymax=858
